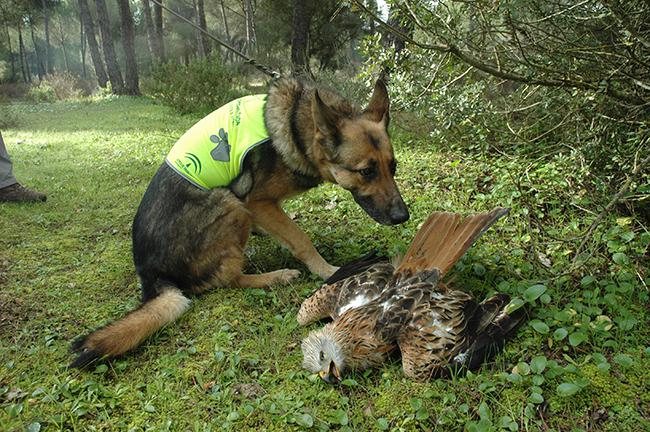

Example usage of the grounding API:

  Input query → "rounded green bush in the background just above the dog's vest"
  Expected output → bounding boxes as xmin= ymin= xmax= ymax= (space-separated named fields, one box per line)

xmin=143 ymin=59 xmax=242 ymax=114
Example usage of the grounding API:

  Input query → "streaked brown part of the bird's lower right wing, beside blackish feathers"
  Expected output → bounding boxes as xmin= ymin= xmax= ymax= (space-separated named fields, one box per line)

xmin=398 ymin=290 xmax=477 ymax=380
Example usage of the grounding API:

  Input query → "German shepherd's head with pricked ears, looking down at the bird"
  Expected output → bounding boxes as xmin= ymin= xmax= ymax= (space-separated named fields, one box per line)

xmin=312 ymin=80 xmax=409 ymax=225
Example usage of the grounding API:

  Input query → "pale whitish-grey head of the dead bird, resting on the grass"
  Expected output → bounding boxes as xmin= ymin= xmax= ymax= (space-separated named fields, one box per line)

xmin=302 ymin=324 xmax=345 ymax=384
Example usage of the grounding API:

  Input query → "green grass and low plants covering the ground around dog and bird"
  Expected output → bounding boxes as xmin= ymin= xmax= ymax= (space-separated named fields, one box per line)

xmin=0 ymin=97 xmax=650 ymax=431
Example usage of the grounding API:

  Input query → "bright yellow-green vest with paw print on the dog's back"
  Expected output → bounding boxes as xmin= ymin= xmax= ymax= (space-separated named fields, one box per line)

xmin=166 ymin=95 xmax=271 ymax=190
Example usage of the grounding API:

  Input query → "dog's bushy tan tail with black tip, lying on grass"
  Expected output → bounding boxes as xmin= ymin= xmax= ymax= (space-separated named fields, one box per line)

xmin=70 ymin=286 xmax=190 ymax=367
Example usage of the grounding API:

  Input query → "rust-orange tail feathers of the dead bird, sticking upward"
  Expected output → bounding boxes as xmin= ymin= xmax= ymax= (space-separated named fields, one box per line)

xmin=395 ymin=207 xmax=509 ymax=279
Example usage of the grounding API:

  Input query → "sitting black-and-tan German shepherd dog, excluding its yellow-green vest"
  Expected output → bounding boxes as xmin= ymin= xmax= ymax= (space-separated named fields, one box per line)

xmin=71 ymin=78 xmax=409 ymax=367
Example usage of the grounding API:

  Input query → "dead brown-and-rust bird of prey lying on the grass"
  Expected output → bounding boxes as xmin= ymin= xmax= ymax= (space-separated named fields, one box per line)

xmin=299 ymin=208 xmax=523 ymax=382
